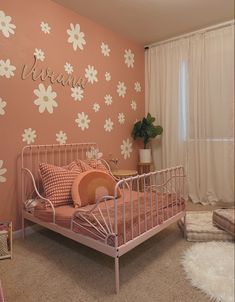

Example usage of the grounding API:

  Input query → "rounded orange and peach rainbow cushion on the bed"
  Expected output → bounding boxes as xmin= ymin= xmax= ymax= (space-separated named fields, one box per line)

xmin=72 ymin=170 xmax=119 ymax=207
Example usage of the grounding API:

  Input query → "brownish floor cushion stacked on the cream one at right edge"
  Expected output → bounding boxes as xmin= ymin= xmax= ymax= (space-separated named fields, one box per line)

xmin=213 ymin=208 xmax=235 ymax=237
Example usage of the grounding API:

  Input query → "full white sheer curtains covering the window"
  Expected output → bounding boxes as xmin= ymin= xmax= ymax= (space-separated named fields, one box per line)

xmin=145 ymin=25 xmax=234 ymax=204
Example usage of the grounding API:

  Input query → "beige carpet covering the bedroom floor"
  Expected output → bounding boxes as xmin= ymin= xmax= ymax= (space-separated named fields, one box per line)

xmin=0 ymin=201 xmax=231 ymax=302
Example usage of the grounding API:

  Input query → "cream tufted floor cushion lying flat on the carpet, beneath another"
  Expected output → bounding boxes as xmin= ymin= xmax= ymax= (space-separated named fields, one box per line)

xmin=178 ymin=211 xmax=233 ymax=241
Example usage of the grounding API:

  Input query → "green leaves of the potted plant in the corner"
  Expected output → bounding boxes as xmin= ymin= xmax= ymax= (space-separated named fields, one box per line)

xmin=131 ymin=113 xmax=163 ymax=149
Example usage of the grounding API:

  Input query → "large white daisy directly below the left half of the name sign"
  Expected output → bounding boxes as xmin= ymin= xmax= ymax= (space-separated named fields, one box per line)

xmin=33 ymin=84 xmax=58 ymax=113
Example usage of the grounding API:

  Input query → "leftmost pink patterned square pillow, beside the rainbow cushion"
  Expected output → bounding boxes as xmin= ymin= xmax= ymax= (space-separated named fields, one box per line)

xmin=39 ymin=163 xmax=79 ymax=207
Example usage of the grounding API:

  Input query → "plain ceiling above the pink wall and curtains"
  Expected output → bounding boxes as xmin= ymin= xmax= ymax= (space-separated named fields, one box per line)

xmin=53 ymin=0 xmax=234 ymax=45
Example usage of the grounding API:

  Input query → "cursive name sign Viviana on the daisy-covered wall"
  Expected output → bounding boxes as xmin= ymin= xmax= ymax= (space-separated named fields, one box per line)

xmin=21 ymin=56 xmax=87 ymax=89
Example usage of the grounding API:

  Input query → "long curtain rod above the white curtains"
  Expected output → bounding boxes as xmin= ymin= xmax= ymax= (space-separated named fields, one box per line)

xmin=144 ymin=19 xmax=234 ymax=49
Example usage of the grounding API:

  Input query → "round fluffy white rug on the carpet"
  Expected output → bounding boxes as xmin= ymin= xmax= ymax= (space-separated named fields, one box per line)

xmin=182 ymin=241 xmax=235 ymax=302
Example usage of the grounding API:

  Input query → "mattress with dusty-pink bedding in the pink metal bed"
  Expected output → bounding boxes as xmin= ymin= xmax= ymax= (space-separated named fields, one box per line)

xmin=32 ymin=190 xmax=185 ymax=246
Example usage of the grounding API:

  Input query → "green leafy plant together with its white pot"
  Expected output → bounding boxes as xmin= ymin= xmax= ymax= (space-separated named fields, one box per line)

xmin=131 ymin=113 xmax=163 ymax=163
